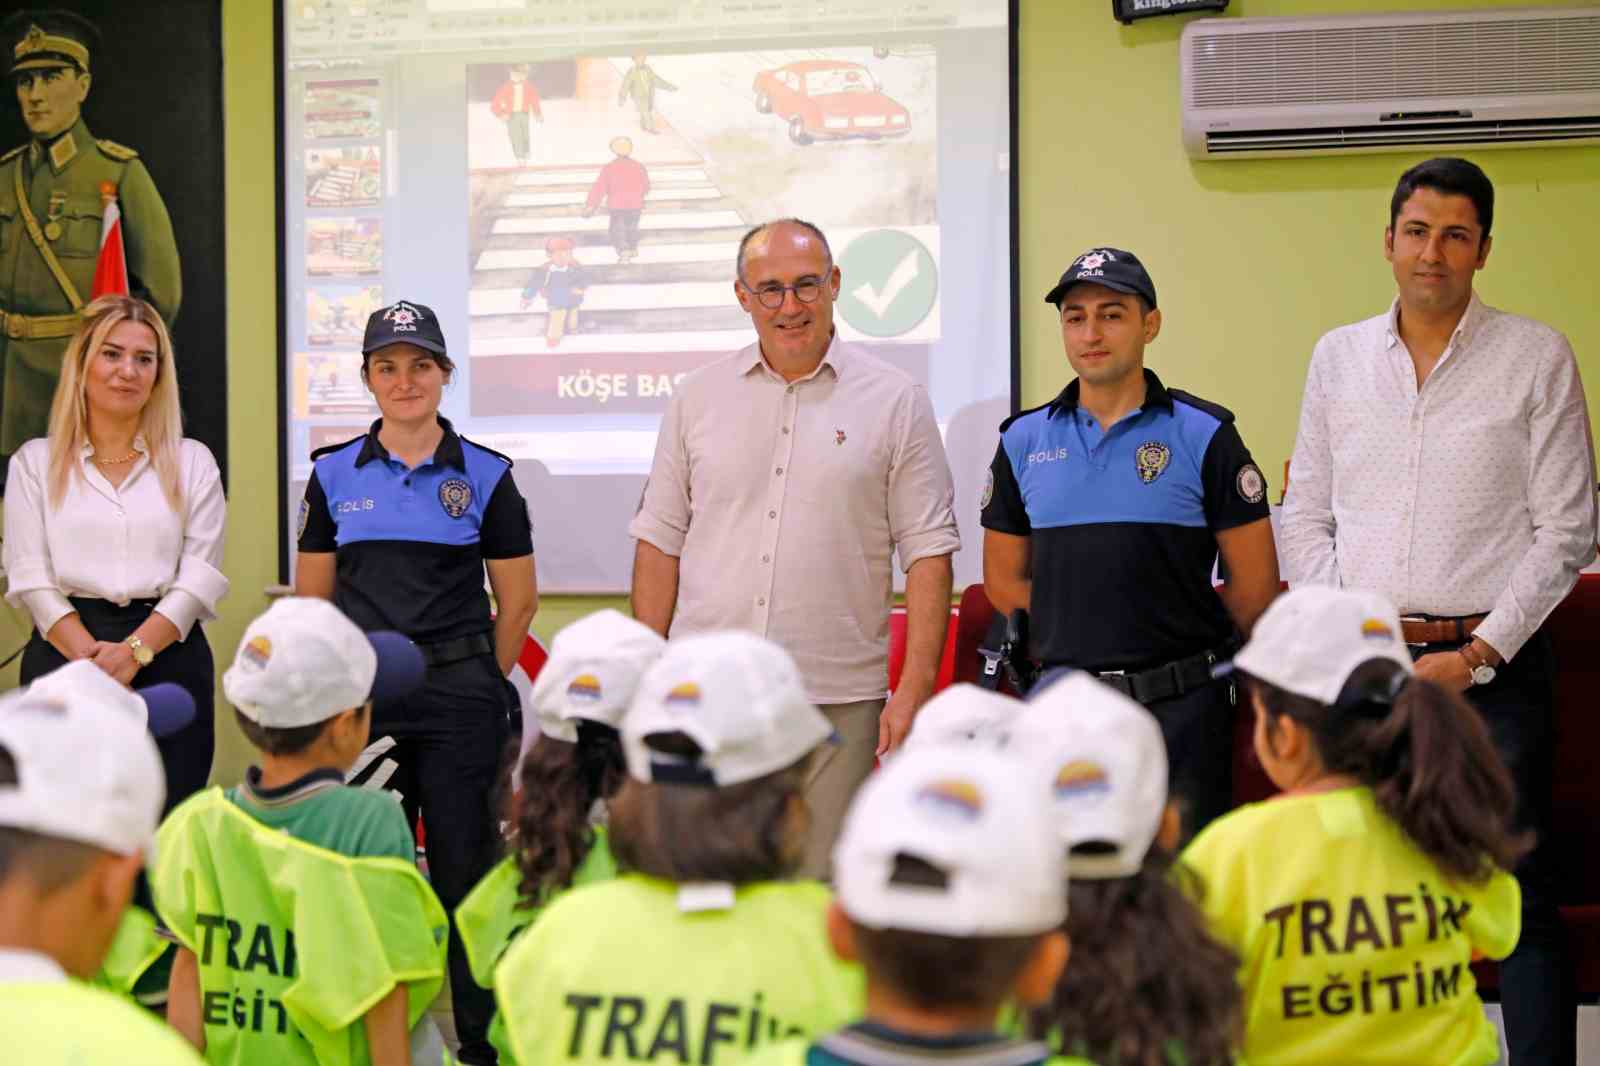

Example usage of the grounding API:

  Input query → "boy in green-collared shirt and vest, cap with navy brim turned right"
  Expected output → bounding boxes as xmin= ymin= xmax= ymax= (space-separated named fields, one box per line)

xmin=150 ymin=597 xmax=448 ymax=1066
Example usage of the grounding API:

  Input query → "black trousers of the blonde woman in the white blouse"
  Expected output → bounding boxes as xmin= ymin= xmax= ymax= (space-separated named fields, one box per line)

xmin=21 ymin=597 xmax=216 ymax=816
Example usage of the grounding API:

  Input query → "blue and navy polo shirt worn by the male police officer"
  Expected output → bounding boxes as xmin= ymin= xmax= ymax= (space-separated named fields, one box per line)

xmin=982 ymin=370 xmax=1269 ymax=671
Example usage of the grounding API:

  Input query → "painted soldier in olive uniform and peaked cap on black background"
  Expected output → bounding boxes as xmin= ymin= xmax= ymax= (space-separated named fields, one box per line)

xmin=0 ymin=11 xmax=182 ymax=456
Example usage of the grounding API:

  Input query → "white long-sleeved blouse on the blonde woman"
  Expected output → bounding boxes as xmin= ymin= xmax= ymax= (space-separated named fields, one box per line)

xmin=0 ymin=437 xmax=227 ymax=640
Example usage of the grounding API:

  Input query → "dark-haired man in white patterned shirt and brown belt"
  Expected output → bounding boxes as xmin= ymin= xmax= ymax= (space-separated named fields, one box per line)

xmin=1280 ymin=158 xmax=1595 ymax=1066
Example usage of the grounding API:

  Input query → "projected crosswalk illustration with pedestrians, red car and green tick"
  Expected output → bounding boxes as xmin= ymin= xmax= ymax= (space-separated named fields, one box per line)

xmin=466 ymin=45 xmax=939 ymax=415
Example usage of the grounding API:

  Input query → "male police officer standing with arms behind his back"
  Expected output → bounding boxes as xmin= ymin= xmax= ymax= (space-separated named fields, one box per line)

xmin=982 ymin=248 xmax=1278 ymax=832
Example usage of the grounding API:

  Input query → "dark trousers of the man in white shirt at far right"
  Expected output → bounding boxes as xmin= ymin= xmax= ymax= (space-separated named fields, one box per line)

xmin=1413 ymin=632 xmax=1578 ymax=1066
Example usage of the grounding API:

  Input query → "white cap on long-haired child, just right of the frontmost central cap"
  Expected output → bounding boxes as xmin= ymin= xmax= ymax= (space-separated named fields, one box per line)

xmin=1011 ymin=672 xmax=1166 ymax=880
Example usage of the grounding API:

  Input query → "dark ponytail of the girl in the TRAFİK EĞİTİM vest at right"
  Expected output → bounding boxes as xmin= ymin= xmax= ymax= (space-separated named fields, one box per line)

xmin=1243 ymin=659 xmax=1531 ymax=884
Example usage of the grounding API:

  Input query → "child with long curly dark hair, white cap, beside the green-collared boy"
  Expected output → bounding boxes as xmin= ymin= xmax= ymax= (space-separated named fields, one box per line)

xmin=456 ymin=610 xmax=667 ymax=1066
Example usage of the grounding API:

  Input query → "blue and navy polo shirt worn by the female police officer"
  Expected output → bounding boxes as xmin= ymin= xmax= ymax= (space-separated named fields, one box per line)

xmin=299 ymin=418 xmax=533 ymax=643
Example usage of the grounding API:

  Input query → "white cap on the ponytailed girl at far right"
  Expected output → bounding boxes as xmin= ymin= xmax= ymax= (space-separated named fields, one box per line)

xmin=1219 ymin=586 xmax=1411 ymax=706
